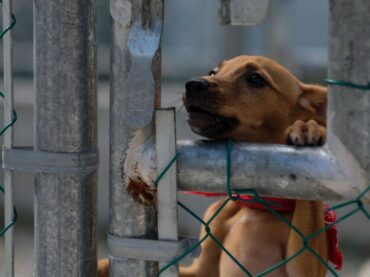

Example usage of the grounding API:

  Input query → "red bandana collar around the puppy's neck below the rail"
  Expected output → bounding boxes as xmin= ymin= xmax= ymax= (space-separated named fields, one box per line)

xmin=184 ymin=191 xmax=343 ymax=270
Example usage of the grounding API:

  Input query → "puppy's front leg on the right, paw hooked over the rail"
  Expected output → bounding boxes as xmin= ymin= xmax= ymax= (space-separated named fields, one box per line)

xmin=285 ymin=120 xmax=328 ymax=277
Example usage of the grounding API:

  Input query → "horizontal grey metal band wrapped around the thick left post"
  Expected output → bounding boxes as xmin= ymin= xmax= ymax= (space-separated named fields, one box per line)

xmin=2 ymin=147 xmax=99 ymax=174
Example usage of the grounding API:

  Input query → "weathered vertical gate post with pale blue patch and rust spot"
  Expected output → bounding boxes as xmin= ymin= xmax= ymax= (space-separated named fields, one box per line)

xmin=109 ymin=0 xmax=163 ymax=276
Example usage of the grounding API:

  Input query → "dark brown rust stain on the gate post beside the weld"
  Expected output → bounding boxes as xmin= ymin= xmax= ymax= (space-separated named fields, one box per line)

xmin=127 ymin=176 xmax=157 ymax=207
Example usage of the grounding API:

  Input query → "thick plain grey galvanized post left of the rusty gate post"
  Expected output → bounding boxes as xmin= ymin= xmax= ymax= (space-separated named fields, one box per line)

xmin=34 ymin=0 xmax=97 ymax=276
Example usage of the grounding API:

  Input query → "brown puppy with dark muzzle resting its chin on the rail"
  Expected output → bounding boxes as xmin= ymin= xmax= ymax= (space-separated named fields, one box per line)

xmin=180 ymin=56 xmax=328 ymax=277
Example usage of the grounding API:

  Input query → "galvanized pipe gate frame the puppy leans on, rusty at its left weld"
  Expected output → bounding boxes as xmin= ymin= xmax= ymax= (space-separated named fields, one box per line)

xmin=108 ymin=0 xmax=370 ymax=276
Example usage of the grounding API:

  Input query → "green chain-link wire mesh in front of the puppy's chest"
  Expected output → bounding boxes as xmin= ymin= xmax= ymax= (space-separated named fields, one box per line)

xmin=154 ymin=140 xmax=370 ymax=277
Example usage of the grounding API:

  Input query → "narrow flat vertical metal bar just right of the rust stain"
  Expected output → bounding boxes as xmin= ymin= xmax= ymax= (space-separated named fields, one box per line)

xmin=155 ymin=109 xmax=179 ymax=277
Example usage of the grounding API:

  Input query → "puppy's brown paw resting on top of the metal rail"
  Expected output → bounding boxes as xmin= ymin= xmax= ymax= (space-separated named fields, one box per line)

xmin=285 ymin=120 xmax=326 ymax=146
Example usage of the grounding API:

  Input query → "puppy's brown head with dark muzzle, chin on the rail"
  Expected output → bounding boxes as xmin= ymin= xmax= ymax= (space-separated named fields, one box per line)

xmin=184 ymin=56 xmax=326 ymax=143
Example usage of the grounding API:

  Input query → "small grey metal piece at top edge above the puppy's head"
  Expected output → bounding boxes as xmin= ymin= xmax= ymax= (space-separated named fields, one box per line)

xmin=220 ymin=0 xmax=269 ymax=25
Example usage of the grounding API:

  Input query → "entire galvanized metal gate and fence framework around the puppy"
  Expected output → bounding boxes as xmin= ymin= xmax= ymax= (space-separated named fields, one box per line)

xmin=3 ymin=0 xmax=370 ymax=276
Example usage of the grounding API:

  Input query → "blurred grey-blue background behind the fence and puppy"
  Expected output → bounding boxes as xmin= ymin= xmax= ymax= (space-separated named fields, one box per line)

xmin=0 ymin=0 xmax=370 ymax=277
